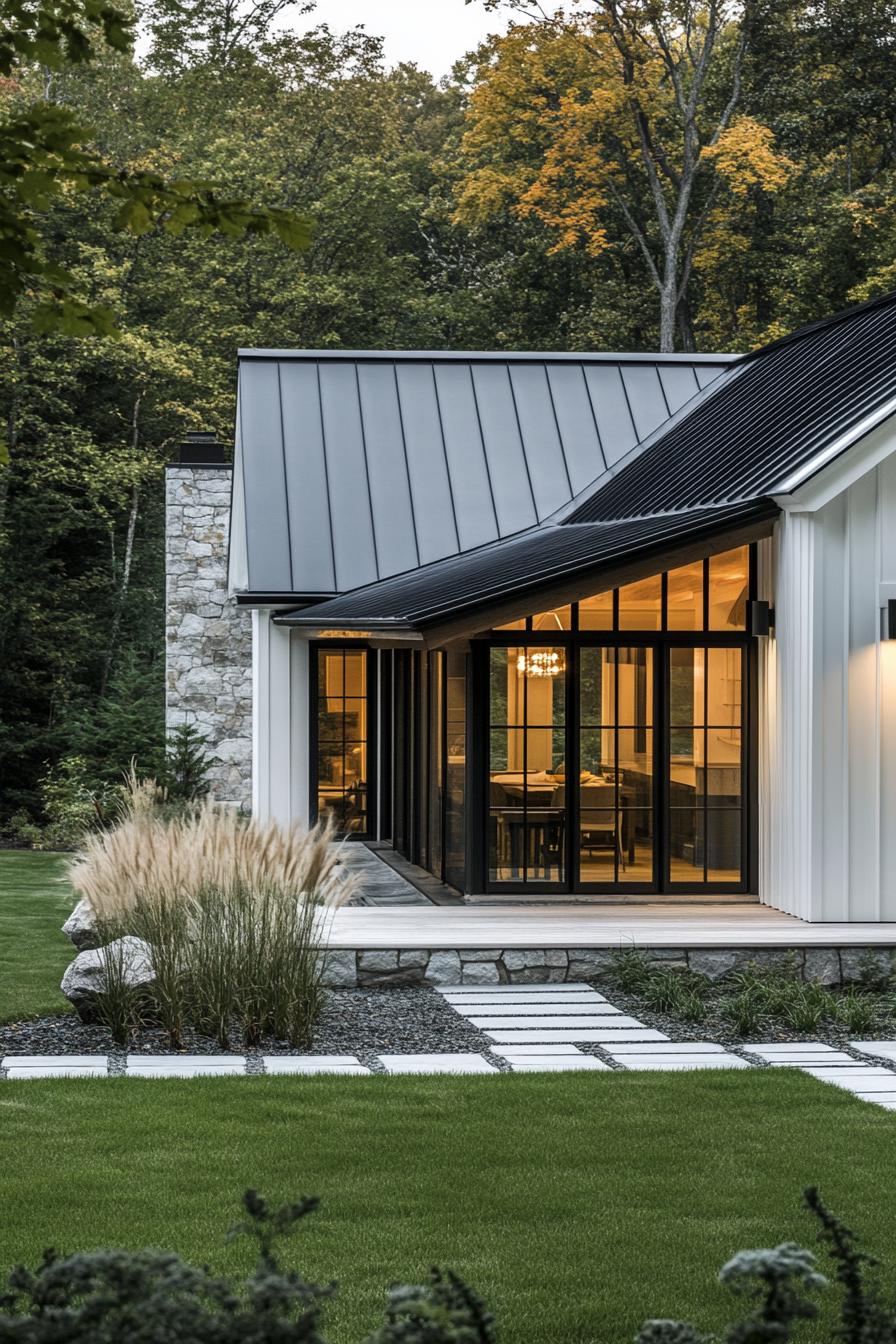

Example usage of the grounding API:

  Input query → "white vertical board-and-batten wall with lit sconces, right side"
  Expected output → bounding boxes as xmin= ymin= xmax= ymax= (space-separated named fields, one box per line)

xmin=759 ymin=421 xmax=896 ymax=921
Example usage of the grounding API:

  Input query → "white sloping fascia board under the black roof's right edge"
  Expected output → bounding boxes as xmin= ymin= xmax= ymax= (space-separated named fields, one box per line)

xmin=771 ymin=398 xmax=896 ymax=513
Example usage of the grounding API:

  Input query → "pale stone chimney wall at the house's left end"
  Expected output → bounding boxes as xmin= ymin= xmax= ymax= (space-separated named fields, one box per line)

xmin=165 ymin=466 xmax=253 ymax=809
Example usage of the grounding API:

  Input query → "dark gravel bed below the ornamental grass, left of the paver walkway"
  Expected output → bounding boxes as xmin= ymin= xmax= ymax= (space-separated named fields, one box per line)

xmin=0 ymin=988 xmax=498 ymax=1071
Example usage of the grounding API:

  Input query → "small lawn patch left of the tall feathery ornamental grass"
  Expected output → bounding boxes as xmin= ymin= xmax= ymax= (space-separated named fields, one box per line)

xmin=0 ymin=849 xmax=75 ymax=1023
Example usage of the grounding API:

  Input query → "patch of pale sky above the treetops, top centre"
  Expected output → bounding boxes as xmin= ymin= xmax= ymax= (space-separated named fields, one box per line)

xmin=295 ymin=0 xmax=508 ymax=78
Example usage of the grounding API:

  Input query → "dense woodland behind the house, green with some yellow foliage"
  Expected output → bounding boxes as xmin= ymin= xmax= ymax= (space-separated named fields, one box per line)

xmin=0 ymin=0 xmax=896 ymax=825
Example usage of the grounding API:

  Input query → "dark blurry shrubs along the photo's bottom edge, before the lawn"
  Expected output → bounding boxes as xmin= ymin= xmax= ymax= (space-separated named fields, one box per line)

xmin=0 ymin=1189 xmax=896 ymax=1344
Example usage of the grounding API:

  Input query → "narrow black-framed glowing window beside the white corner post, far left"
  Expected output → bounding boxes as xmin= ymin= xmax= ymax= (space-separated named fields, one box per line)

xmin=317 ymin=648 xmax=369 ymax=835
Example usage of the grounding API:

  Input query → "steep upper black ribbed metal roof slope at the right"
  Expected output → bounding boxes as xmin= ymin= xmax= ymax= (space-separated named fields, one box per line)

xmin=568 ymin=294 xmax=896 ymax=523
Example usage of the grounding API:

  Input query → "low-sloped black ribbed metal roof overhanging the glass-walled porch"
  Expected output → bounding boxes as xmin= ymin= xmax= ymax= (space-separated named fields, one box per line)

xmin=277 ymin=500 xmax=778 ymax=630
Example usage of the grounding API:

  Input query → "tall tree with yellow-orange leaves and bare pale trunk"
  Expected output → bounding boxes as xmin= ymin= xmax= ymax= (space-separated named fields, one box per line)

xmin=457 ymin=0 xmax=791 ymax=351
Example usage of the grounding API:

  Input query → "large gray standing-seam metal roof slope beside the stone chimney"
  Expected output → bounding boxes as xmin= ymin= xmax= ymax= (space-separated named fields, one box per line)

xmin=234 ymin=351 xmax=728 ymax=595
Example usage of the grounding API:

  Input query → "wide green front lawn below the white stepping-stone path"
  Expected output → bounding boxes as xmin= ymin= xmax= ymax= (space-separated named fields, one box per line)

xmin=0 ymin=1070 xmax=896 ymax=1344
